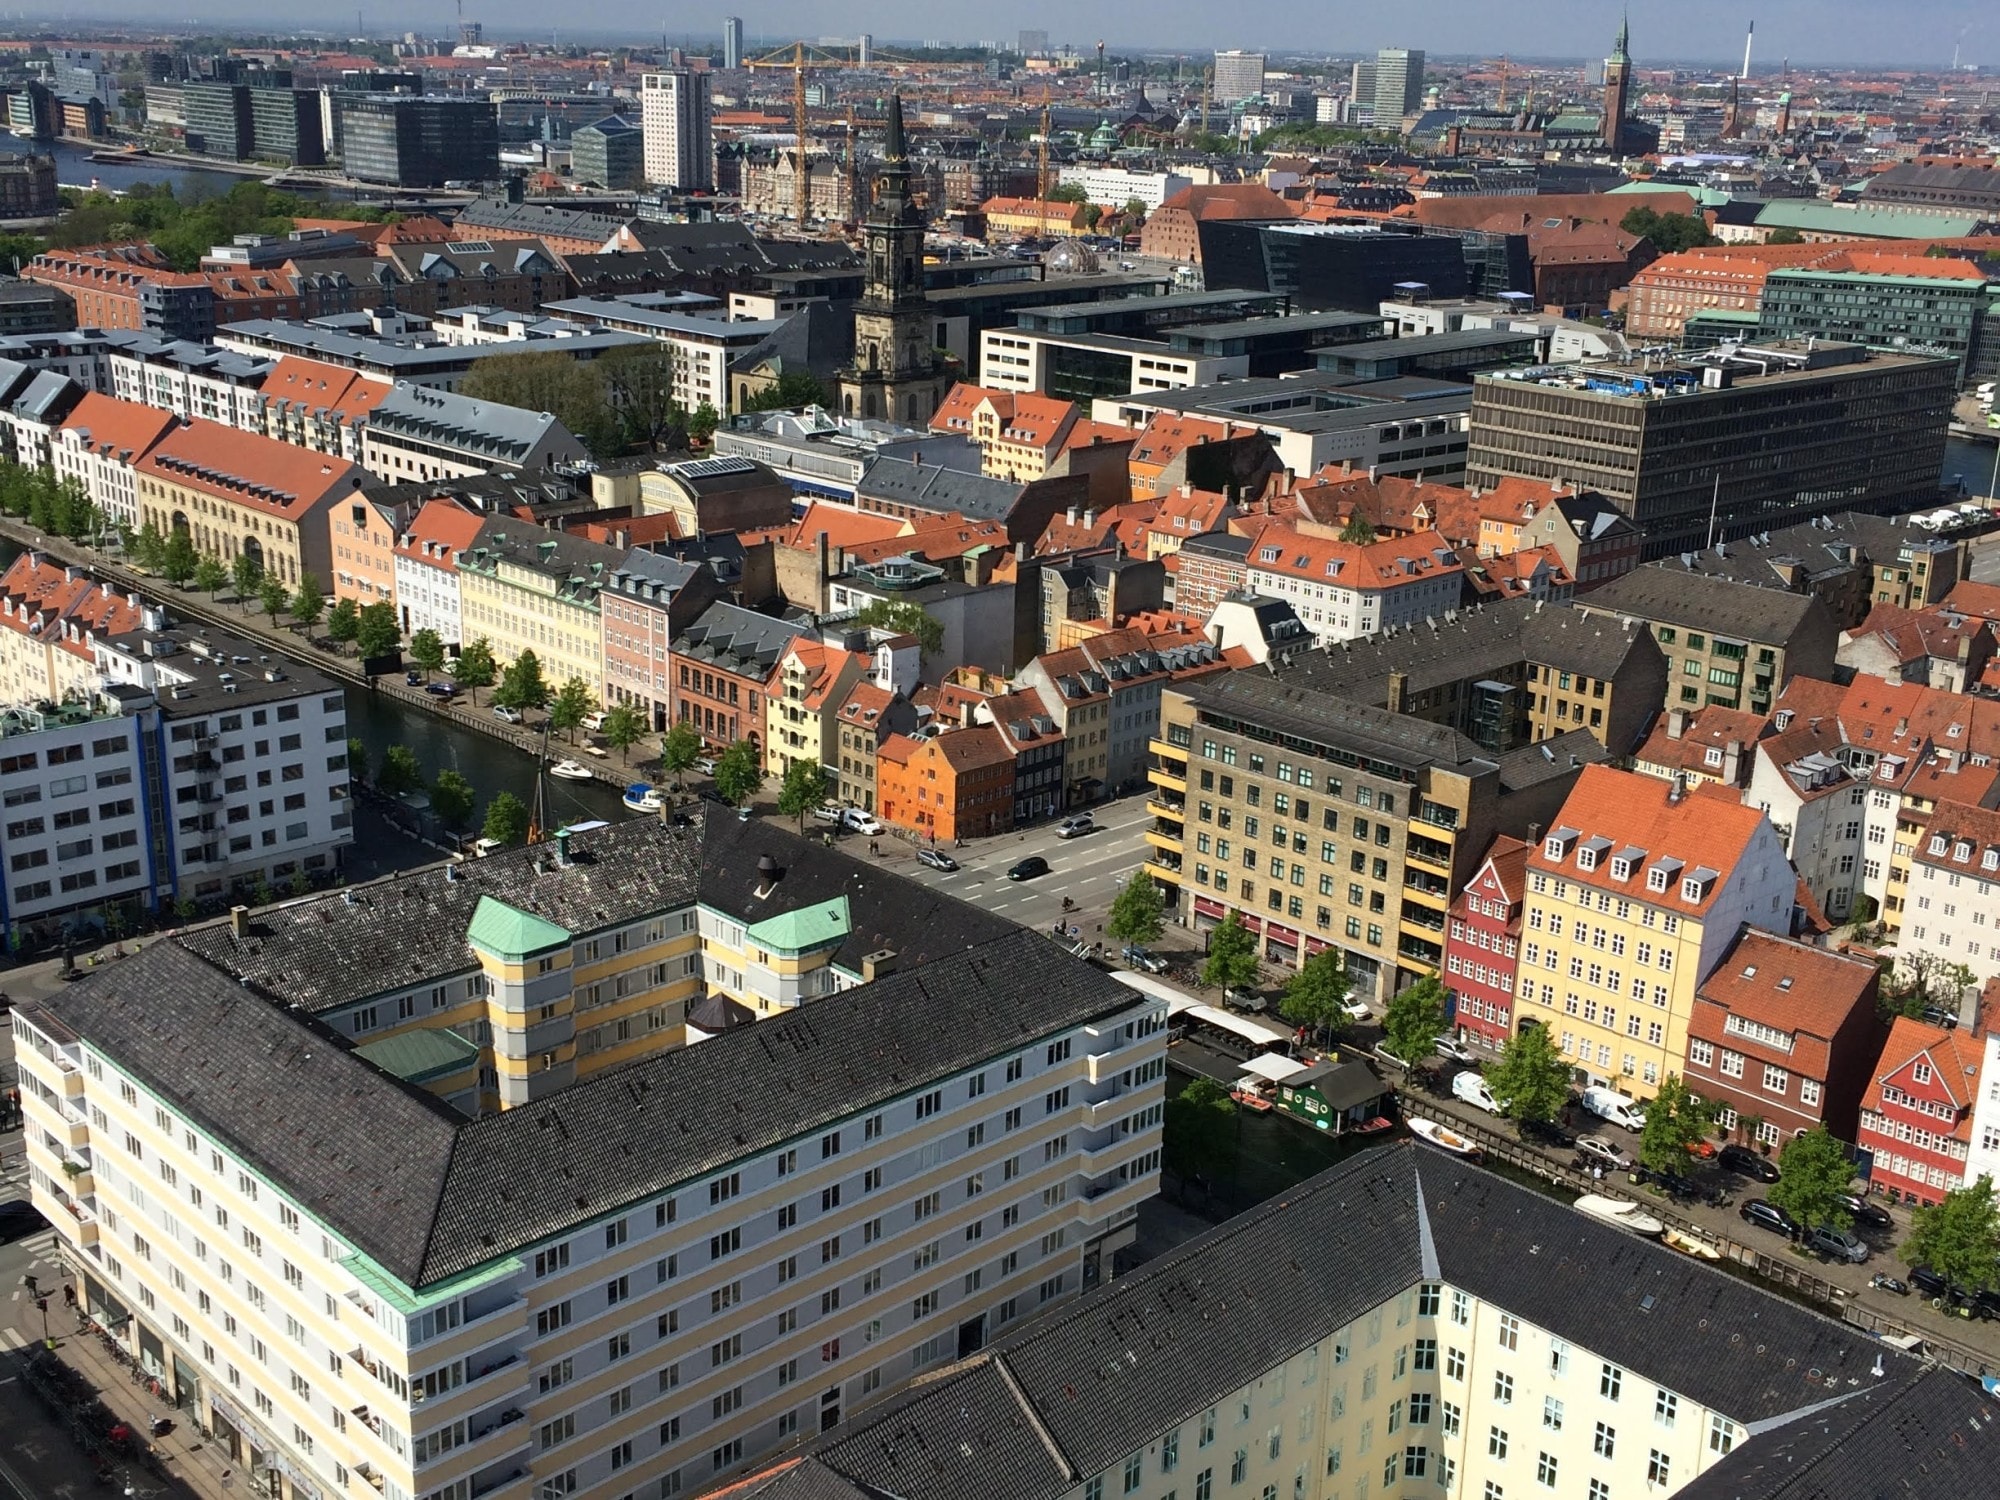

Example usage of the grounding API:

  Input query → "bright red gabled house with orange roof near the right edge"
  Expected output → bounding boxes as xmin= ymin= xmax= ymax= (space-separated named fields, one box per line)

xmin=1854 ymin=1016 xmax=1986 ymax=1204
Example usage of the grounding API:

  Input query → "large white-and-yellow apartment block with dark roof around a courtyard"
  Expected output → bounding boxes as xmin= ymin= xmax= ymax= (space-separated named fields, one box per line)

xmin=14 ymin=818 xmax=1166 ymax=1500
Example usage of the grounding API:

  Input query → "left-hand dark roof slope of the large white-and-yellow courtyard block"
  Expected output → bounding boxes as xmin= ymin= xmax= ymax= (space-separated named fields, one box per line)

xmin=32 ymin=942 xmax=462 ymax=1268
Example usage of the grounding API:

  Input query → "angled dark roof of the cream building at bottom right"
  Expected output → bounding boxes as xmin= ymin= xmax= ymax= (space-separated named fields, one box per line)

xmin=752 ymin=1142 xmax=1920 ymax=1500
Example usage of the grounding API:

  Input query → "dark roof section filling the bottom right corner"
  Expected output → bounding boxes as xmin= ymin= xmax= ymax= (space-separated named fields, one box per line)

xmin=1672 ymin=1366 xmax=2000 ymax=1500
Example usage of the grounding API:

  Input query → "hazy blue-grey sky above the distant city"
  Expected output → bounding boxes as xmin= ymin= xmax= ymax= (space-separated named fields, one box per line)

xmin=15 ymin=0 xmax=2000 ymax=68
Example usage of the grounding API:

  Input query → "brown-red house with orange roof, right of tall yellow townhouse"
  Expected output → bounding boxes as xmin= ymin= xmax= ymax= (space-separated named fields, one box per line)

xmin=1682 ymin=928 xmax=1882 ymax=1150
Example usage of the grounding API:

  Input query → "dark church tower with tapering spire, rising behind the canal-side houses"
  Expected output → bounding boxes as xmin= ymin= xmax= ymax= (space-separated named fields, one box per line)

xmin=840 ymin=94 xmax=952 ymax=426
